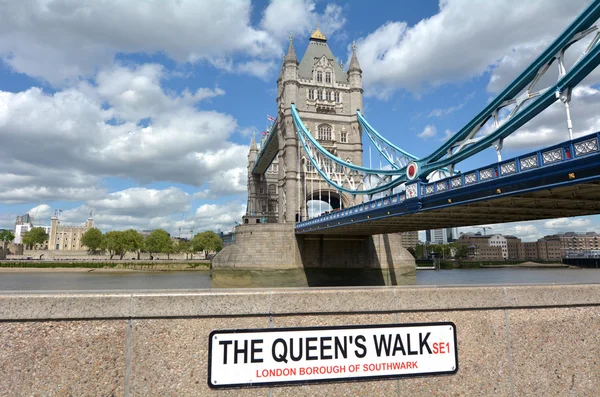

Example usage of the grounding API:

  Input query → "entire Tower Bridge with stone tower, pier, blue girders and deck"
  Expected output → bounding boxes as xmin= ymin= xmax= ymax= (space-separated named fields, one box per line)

xmin=213 ymin=0 xmax=600 ymax=284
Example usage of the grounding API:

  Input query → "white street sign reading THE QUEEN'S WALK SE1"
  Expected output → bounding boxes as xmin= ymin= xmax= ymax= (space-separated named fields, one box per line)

xmin=208 ymin=322 xmax=458 ymax=388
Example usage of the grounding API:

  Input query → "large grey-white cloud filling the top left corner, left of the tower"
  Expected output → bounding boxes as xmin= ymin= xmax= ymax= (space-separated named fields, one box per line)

xmin=0 ymin=0 xmax=281 ymax=84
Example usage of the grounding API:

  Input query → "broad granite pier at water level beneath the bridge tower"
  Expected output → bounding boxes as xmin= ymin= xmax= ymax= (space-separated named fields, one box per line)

xmin=212 ymin=223 xmax=416 ymax=288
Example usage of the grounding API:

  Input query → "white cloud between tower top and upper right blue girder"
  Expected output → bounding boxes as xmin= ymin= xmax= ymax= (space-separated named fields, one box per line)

xmin=357 ymin=0 xmax=588 ymax=98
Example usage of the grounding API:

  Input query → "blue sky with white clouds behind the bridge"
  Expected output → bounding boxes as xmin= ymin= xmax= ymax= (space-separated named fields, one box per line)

xmin=0 ymin=0 xmax=600 ymax=240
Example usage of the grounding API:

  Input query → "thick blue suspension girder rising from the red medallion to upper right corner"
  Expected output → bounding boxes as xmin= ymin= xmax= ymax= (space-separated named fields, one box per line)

xmin=416 ymin=0 xmax=600 ymax=177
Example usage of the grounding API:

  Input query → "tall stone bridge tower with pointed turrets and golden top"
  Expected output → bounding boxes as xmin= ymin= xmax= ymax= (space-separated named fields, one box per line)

xmin=277 ymin=27 xmax=363 ymax=223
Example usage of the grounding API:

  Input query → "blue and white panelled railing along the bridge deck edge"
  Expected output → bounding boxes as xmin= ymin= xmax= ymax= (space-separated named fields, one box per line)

xmin=296 ymin=132 xmax=600 ymax=230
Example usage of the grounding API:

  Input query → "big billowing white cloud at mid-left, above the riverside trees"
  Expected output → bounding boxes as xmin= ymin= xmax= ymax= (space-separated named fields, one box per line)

xmin=0 ymin=65 xmax=248 ymax=203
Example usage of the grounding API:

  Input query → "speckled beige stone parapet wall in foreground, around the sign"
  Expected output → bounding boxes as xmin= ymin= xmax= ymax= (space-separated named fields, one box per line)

xmin=0 ymin=285 xmax=600 ymax=396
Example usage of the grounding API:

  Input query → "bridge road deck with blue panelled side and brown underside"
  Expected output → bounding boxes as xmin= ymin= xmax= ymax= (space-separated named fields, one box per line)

xmin=295 ymin=133 xmax=600 ymax=235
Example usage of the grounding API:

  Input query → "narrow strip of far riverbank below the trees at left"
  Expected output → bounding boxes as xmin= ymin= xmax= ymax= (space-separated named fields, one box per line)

xmin=0 ymin=260 xmax=210 ymax=272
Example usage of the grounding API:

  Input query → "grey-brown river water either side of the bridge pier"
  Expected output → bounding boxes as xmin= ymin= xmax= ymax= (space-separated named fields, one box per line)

xmin=0 ymin=268 xmax=600 ymax=293
